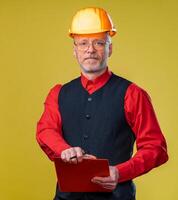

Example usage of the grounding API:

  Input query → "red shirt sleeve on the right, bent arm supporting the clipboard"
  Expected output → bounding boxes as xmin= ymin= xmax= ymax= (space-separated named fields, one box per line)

xmin=116 ymin=84 xmax=168 ymax=182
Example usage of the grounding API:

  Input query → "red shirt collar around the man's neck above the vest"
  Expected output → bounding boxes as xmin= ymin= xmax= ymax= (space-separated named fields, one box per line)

xmin=81 ymin=68 xmax=112 ymax=94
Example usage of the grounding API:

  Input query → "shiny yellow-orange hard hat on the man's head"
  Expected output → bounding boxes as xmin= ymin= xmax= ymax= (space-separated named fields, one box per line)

xmin=69 ymin=7 xmax=116 ymax=37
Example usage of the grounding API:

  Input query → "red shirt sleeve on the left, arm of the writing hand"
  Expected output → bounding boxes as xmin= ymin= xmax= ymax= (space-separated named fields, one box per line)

xmin=36 ymin=85 xmax=70 ymax=160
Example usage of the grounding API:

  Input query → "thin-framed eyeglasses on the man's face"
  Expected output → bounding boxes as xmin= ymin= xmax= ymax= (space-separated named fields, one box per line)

xmin=74 ymin=40 xmax=108 ymax=51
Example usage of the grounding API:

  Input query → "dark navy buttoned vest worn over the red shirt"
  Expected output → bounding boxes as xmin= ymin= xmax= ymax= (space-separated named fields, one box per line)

xmin=55 ymin=74 xmax=135 ymax=200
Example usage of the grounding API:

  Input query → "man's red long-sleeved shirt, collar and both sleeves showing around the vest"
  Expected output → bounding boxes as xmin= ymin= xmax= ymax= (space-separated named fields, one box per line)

xmin=36 ymin=69 xmax=168 ymax=182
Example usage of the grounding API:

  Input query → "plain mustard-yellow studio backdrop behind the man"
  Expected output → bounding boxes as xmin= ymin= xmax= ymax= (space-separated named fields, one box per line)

xmin=0 ymin=0 xmax=178 ymax=200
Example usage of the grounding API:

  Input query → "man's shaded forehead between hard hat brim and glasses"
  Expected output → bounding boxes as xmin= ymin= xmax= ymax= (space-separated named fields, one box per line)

xmin=74 ymin=33 xmax=107 ymax=40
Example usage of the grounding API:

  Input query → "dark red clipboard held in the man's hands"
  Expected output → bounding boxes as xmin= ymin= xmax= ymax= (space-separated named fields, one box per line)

xmin=54 ymin=158 xmax=111 ymax=192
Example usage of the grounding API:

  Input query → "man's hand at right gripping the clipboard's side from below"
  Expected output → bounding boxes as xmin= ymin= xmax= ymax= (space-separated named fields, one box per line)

xmin=91 ymin=166 xmax=119 ymax=190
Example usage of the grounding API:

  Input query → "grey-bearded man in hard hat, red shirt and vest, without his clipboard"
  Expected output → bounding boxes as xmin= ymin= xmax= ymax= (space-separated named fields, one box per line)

xmin=37 ymin=7 xmax=168 ymax=200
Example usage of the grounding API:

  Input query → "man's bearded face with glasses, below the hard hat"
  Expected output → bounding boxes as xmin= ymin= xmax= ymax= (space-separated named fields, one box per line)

xmin=74 ymin=33 xmax=112 ymax=73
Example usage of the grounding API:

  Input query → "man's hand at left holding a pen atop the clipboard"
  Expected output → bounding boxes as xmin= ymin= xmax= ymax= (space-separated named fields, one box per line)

xmin=61 ymin=147 xmax=96 ymax=164
